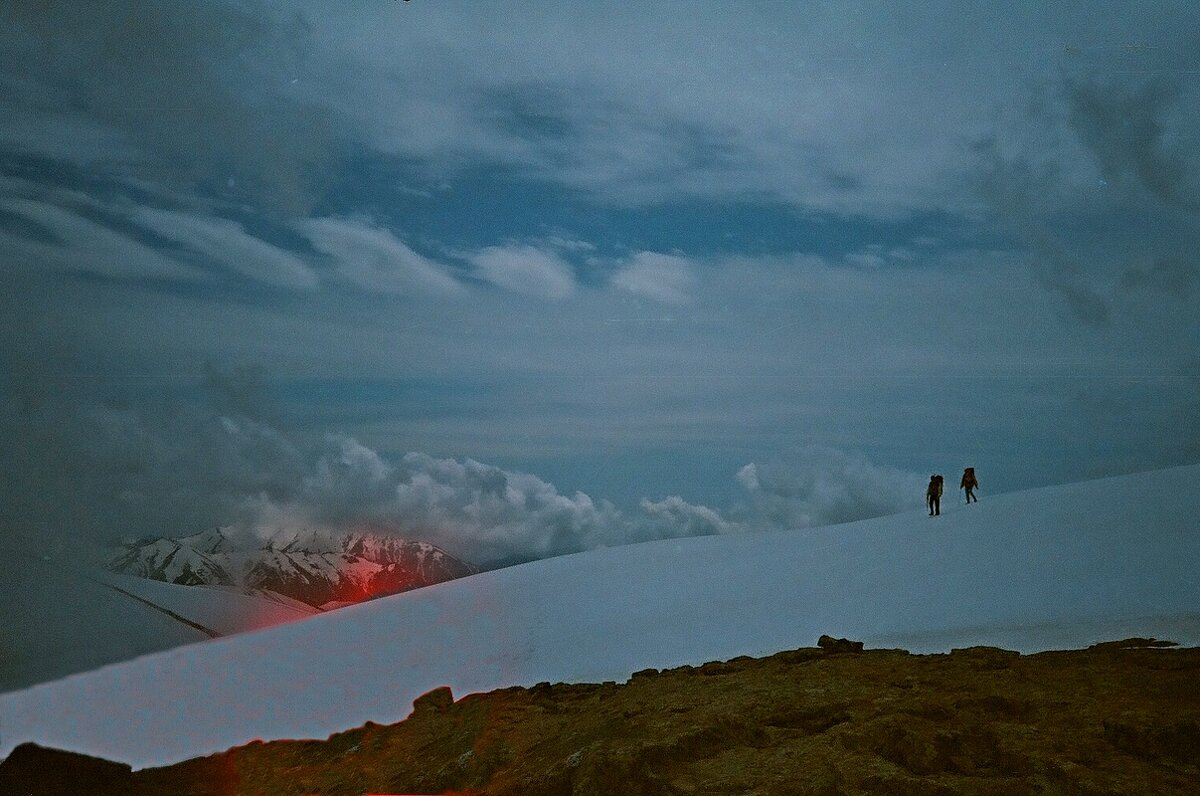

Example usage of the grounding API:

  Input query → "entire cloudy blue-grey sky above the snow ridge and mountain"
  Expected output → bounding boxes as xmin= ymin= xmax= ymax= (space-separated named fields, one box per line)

xmin=0 ymin=0 xmax=1200 ymax=564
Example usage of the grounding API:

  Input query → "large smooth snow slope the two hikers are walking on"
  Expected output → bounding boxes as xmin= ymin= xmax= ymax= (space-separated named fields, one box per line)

xmin=0 ymin=466 xmax=1200 ymax=767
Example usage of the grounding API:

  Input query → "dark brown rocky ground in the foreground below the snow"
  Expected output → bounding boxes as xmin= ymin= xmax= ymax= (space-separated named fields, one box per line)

xmin=0 ymin=638 xmax=1200 ymax=796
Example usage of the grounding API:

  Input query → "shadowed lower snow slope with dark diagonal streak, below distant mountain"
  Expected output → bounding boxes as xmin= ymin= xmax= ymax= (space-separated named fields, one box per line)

xmin=0 ymin=551 xmax=317 ymax=696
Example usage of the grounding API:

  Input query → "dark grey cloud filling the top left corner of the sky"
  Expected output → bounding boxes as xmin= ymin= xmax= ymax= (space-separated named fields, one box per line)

xmin=0 ymin=0 xmax=331 ymax=211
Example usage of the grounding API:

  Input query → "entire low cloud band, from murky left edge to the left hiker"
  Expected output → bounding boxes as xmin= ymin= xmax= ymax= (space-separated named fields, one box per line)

xmin=0 ymin=369 xmax=920 ymax=567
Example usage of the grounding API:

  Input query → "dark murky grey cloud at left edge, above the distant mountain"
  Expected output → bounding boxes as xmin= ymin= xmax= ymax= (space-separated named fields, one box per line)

xmin=0 ymin=374 xmax=306 ymax=550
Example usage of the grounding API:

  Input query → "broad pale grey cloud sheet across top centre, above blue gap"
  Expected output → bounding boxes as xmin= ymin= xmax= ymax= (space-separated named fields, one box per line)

xmin=312 ymin=4 xmax=1070 ymax=216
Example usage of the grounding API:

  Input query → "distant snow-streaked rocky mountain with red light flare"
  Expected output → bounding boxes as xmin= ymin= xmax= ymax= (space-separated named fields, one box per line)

xmin=107 ymin=528 xmax=478 ymax=610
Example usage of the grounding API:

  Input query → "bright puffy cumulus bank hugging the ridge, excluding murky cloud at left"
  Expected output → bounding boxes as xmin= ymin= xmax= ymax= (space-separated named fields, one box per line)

xmin=244 ymin=435 xmax=924 ymax=565
